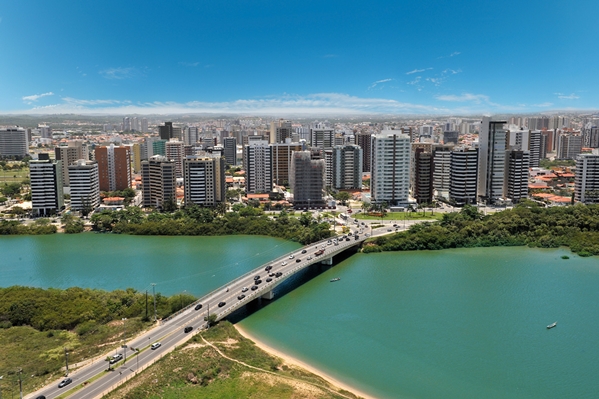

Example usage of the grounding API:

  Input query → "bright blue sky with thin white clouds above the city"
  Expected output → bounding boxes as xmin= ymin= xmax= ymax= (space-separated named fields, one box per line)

xmin=0 ymin=0 xmax=599 ymax=115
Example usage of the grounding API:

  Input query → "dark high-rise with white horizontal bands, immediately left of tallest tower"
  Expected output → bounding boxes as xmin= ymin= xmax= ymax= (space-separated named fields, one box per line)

xmin=449 ymin=148 xmax=480 ymax=206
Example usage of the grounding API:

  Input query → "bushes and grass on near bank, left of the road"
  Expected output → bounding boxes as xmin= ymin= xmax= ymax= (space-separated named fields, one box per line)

xmin=0 ymin=286 xmax=195 ymax=397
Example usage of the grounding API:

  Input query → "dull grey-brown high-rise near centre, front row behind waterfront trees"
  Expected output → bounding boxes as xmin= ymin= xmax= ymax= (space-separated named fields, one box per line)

xmin=289 ymin=151 xmax=325 ymax=208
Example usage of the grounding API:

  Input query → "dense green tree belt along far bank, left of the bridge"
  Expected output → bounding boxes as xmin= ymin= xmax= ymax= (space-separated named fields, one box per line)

xmin=91 ymin=205 xmax=332 ymax=244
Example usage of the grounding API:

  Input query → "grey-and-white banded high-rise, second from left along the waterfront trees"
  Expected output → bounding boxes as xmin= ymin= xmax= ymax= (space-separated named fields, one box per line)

xmin=68 ymin=159 xmax=100 ymax=213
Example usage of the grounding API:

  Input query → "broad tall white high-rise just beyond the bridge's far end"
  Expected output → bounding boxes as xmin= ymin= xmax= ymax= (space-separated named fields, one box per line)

xmin=370 ymin=130 xmax=410 ymax=205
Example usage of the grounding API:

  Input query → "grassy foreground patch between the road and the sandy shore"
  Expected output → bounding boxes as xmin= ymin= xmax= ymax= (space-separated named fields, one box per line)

xmin=107 ymin=322 xmax=355 ymax=399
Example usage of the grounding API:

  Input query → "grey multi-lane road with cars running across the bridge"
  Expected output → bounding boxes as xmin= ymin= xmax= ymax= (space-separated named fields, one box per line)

xmin=26 ymin=224 xmax=420 ymax=399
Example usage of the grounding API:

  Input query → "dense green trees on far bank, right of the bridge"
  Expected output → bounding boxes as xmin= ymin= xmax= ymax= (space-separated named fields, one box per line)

xmin=364 ymin=201 xmax=599 ymax=256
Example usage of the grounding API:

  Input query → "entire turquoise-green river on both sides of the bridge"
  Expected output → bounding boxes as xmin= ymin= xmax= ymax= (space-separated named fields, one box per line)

xmin=0 ymin=234 xmax=599 ymax=399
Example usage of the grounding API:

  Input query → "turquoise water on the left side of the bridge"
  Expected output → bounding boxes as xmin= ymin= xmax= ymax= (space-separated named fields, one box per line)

xmin=0 ymin=233 xmax=300 ymax=296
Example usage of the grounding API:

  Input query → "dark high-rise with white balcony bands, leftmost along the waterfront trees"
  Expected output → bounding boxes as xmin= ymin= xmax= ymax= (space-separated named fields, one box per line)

xmin=29 ymin=154 xmax=64 ymax=216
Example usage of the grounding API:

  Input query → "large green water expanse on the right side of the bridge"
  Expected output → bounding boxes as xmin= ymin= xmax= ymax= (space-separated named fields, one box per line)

xmin=240 ymin=248 xmax=599 ymax=399
